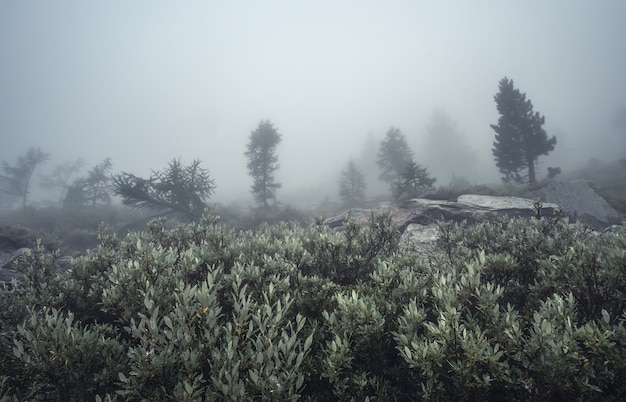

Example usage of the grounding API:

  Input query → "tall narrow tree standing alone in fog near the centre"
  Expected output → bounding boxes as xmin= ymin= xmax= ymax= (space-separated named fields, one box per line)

xmin=245 ymin=120 xmax=281 ymax=208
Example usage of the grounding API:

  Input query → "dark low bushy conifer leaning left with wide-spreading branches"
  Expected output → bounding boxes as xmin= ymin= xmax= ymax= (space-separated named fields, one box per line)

xmin=113 ymin=159 xmax=215 ymax=221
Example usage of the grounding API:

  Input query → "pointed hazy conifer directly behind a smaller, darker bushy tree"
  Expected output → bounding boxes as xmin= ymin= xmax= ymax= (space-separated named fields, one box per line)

xmin=377 ymin=127 xmax=413 ymax=189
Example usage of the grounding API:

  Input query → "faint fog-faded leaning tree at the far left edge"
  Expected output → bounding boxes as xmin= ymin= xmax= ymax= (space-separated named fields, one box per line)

xmin=0 ymin=148 xmax=50 ymax=208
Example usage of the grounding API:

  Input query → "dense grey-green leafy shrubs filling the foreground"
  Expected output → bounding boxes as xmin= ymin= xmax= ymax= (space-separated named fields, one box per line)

xmin=0 ymin=210 xmax=626 ymax=401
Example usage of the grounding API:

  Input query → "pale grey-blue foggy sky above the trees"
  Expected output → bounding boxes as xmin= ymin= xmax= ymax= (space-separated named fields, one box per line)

xmin=0 ymin=0 xmax=626 ymax=199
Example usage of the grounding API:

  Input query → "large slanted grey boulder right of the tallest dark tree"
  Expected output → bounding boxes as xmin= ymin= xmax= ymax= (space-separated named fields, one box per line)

xmin=527 ymin=180 xmax=620 ymax=229
